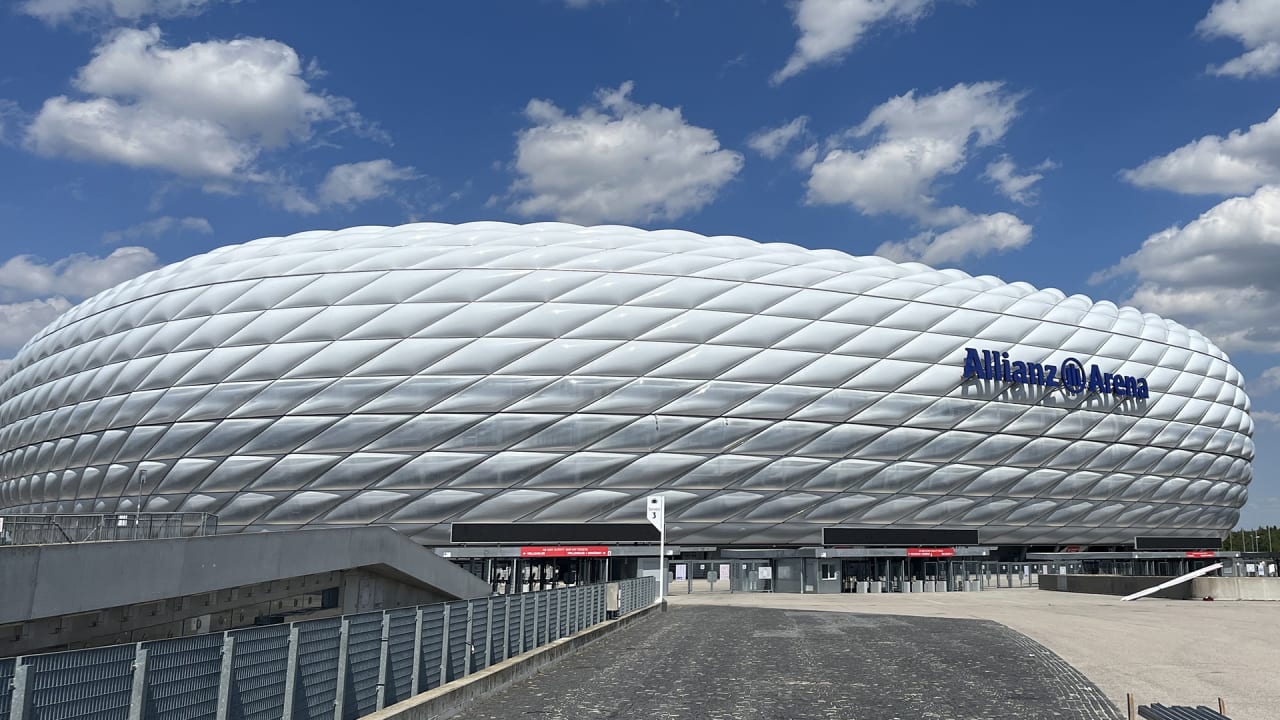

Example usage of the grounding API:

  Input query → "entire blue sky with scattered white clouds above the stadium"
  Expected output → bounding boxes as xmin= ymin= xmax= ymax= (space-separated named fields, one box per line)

xmin=0 ymin=0 xmax=1280 ymax=525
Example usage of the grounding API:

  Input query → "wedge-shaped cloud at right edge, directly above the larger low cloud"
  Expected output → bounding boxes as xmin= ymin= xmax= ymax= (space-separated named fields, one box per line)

xmin=1123 ymin=110 xmax=1280 ymax=195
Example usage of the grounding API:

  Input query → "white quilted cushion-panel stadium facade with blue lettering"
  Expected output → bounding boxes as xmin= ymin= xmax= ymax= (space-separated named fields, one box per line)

xmin=0 ymin=223 xmax=1253 ymax=546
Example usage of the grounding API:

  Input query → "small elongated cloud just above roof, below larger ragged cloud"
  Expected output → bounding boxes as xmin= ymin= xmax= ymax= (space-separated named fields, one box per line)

xmin=876 ymin=213 xmax=1032 ymax=265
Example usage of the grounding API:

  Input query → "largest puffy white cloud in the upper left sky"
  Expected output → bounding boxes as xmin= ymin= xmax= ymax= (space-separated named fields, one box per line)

xmin=27 ymin=27 xmax=360 ymax=181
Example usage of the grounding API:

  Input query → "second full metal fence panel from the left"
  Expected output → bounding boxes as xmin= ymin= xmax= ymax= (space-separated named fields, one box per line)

xmin=142 ymin=633 xmax=223 ymax=720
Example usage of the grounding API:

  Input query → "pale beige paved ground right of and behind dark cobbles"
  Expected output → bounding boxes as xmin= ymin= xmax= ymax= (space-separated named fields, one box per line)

xmin=671 ymin=588 xmax=1280 ymax=720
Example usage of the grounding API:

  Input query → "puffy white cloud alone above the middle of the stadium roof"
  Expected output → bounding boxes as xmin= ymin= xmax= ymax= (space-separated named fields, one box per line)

xmin=511 ymin=82 xmax=742 ymax=223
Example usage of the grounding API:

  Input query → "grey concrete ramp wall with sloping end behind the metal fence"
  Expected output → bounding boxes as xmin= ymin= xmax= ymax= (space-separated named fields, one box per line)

xmin=0 ymin=527 xmax=489 ymax=656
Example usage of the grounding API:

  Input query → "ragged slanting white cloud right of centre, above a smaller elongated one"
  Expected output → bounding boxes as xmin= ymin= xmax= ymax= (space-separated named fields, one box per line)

xmin=808 ymin=82 xmax=1019 ymax=218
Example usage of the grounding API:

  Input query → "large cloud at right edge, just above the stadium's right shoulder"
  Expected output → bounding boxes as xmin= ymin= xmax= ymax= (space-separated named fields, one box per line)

xmin=1091 ymin=186 xmax=1280 ymax=352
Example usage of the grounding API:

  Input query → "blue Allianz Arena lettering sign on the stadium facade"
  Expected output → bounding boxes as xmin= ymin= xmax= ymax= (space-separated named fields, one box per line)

xmin=961 ymin=347 xmax=1151 ymax=398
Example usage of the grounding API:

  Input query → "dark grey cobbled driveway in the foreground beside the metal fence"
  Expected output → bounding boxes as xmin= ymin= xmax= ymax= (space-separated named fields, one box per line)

xmin=457 ymin=596 xmax=1120 ymax=720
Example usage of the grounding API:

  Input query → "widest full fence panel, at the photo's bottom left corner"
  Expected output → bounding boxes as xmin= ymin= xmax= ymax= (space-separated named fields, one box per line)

xmin=26 ymin=644 xmax=137 ymax=720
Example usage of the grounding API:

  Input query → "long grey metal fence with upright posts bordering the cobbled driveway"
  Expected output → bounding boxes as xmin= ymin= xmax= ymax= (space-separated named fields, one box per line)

xmin=0 ymin=578 xmax=657 ymax=720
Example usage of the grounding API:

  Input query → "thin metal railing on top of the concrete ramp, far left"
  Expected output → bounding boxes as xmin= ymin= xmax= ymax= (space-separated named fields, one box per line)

xmin=0 ymin=512 xmax=218 ymax=544
